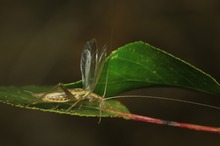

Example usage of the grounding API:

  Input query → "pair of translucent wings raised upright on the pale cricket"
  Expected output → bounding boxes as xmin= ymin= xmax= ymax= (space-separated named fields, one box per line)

xmin=80 ymin=39 xmax=107 ymax=91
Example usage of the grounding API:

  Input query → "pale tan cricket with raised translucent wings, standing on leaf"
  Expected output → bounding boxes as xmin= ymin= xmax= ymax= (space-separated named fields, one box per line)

xmin=29 ymin=39 xmax=107 ymax=117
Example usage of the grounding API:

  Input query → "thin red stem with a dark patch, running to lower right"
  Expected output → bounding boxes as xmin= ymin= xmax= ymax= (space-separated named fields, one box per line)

xmin=103 ymin=109 xmax=220 ymax=134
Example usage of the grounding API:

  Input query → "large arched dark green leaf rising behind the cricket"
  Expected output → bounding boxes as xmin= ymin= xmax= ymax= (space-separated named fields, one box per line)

xmin=66 ymin=41 xmax=220 ymax=96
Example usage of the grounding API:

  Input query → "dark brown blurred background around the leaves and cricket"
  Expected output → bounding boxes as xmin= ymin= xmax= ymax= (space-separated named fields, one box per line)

xmin=0 ymin=0 xmax=220 ymax=146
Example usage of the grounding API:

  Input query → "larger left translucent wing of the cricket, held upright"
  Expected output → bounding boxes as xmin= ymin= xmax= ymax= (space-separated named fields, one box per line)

xmin=80 ymin=39 xmax=98 ymax=91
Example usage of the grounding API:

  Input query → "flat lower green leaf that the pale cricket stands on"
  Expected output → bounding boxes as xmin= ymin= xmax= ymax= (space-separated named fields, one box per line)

xmin=0 ymin=86 xmax=129 ymax=117
